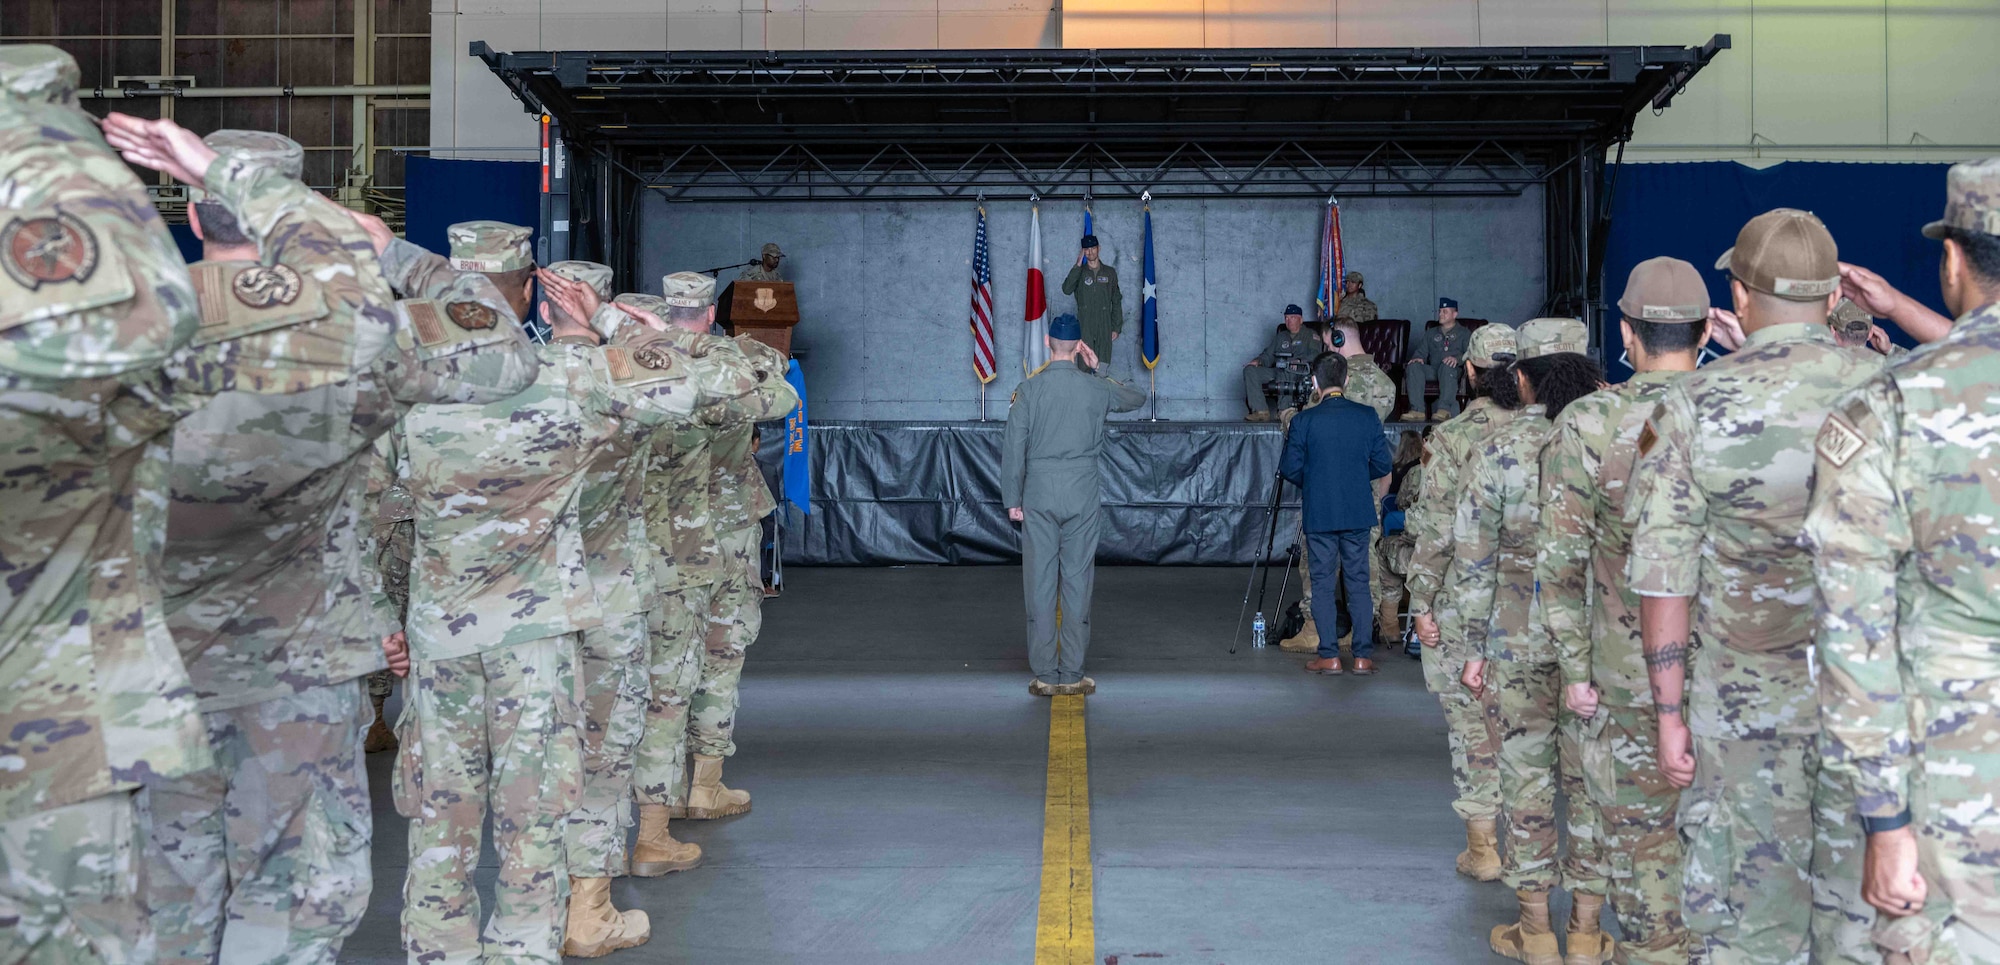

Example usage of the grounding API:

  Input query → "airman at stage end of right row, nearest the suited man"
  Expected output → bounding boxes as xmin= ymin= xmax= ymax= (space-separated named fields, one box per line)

xmin=1404 ymin=324 xmax=1520 ymax=881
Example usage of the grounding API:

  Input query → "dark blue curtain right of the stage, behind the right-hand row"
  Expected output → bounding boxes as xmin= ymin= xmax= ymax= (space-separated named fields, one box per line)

xmin=1602 ymin=160 xmax=1950 ymax=382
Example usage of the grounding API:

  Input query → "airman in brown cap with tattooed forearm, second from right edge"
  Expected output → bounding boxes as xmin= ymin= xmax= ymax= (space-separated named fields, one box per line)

xmin=1626 ymin=208 xmax=1880 ymax=965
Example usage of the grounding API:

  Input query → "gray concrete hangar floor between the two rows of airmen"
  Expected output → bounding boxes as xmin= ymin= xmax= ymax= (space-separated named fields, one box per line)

xmin=342 ymin=567 xmax=1520 ymax=965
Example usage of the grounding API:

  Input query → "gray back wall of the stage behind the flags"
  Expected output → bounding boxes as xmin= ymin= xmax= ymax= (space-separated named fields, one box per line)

xmin=640 ymin=190 xmax=1544 ymax=420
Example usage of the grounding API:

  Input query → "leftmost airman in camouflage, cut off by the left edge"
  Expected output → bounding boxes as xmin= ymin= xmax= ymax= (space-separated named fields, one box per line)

xmin=0 ymin=44 xmax=208 ymax=961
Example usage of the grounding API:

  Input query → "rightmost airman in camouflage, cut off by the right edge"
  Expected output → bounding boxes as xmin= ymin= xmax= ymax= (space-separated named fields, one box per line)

xmin=1804 ymin=158 xmax=2000 ymax=965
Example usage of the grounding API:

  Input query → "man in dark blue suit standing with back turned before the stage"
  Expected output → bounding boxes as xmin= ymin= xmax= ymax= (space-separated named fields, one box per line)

xmin=1278 ymin=352 xmax=1394 ymax=675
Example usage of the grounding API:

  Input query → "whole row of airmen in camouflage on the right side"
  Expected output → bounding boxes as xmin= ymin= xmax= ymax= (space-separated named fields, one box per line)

xmin=1408 ymin=168 xmax=2000 ymax=965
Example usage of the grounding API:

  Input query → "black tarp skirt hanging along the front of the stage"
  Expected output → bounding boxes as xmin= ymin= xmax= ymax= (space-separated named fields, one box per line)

xmin=764 ymin=422 xmax=1298 ymax=567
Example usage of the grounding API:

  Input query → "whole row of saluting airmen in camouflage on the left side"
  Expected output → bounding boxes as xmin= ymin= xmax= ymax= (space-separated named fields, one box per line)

xmin=0 ymin=46 xmax=798 ymax=963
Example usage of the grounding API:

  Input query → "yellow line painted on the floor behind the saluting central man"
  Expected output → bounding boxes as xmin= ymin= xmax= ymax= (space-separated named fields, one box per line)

xmin=1034 ymin=695 xmax=1098 ymax=965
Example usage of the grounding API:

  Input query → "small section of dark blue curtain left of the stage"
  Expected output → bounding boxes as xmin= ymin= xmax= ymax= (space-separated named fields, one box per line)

xmin=404 ymin=154 xmax=542 ymax=254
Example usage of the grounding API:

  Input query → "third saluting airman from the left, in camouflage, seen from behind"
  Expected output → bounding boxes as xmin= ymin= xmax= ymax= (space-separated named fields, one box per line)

xmin=372 ymin=222 xmax=756 ymax=963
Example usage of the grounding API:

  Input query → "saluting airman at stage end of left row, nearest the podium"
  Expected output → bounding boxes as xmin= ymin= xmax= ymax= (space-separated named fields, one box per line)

xmin=638 ymin=326 xmax=798 ymax=817
